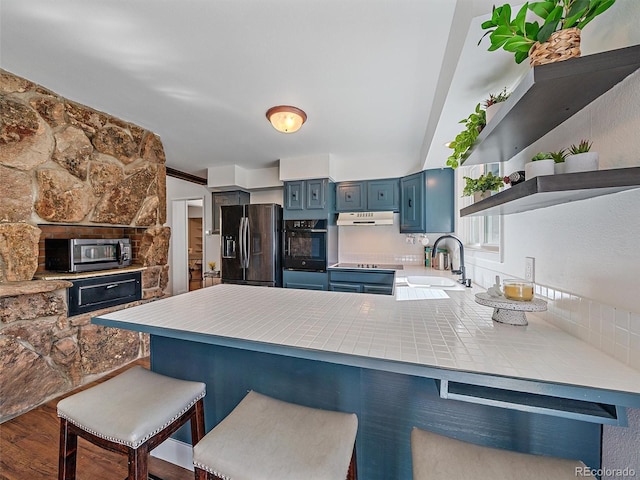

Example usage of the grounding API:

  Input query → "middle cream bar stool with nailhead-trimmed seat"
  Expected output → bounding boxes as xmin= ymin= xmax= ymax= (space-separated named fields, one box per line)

xmin=193 ymin=391 xmax=358 ymax=480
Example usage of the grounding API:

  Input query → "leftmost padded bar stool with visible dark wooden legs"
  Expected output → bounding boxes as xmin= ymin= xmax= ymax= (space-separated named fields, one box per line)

xmin=58 ymin=367 xmax=206 ymax=480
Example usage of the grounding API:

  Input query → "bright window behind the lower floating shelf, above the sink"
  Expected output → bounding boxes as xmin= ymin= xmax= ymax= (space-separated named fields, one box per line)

xmin=459 ymin=163 xmax=502 ymax=253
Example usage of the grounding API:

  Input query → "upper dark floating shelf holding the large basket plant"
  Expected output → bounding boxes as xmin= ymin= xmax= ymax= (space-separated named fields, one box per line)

xmin=464 ymin=45 xmax=640 ymax=166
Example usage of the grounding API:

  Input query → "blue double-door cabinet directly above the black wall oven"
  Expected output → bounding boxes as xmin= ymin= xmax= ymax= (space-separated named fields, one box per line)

xmin=283 ymin=178 xmax=335 ymax=220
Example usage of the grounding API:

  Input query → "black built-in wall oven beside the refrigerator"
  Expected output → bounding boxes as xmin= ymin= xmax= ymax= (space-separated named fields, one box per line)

xmin=282 ymin=220 xmax=330 ymax=272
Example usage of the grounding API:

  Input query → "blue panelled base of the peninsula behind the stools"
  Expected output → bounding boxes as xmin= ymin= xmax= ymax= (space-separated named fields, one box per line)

xmin=151 ymin=335 xmax=601 ymax=480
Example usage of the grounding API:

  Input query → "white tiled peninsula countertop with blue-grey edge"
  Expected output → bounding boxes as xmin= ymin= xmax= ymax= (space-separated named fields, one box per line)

xmin=93 ymin=278 xmax=640 ymax=403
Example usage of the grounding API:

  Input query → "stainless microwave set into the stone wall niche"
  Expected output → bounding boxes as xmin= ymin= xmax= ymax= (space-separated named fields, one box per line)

xmin=44 ymin=238 xmax=131 ymax=272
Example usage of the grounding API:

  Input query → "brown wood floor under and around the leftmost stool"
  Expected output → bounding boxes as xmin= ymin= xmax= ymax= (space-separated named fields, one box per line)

xmin=0 ymin=359 xmax=194 ymax=480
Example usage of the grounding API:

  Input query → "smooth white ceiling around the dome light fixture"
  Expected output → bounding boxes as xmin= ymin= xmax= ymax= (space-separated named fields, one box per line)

xmin=0 ymin=0 xmax=632 ymax=180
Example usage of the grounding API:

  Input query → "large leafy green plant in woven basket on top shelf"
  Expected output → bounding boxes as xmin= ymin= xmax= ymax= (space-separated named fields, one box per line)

xmin=478 ymin=0 xmax=615 ymax=66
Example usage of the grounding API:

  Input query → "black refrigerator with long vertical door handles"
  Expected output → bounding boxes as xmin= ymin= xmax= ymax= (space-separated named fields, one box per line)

xmin=220 ymin=203 xmax=282 ymax=287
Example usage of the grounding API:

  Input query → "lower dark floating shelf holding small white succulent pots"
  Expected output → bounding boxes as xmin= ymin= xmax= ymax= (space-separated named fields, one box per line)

xmin=460 ymin=167 xmax=640 ymax=217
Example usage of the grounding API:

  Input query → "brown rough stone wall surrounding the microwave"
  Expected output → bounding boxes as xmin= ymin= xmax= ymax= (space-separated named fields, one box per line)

xmin=0 ymin=70 xmax=170 ymax=422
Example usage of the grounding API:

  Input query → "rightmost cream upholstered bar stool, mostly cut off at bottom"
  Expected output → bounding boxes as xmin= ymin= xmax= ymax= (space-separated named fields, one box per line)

xmin=411 ymin=427 xmax=587 ymax=480
